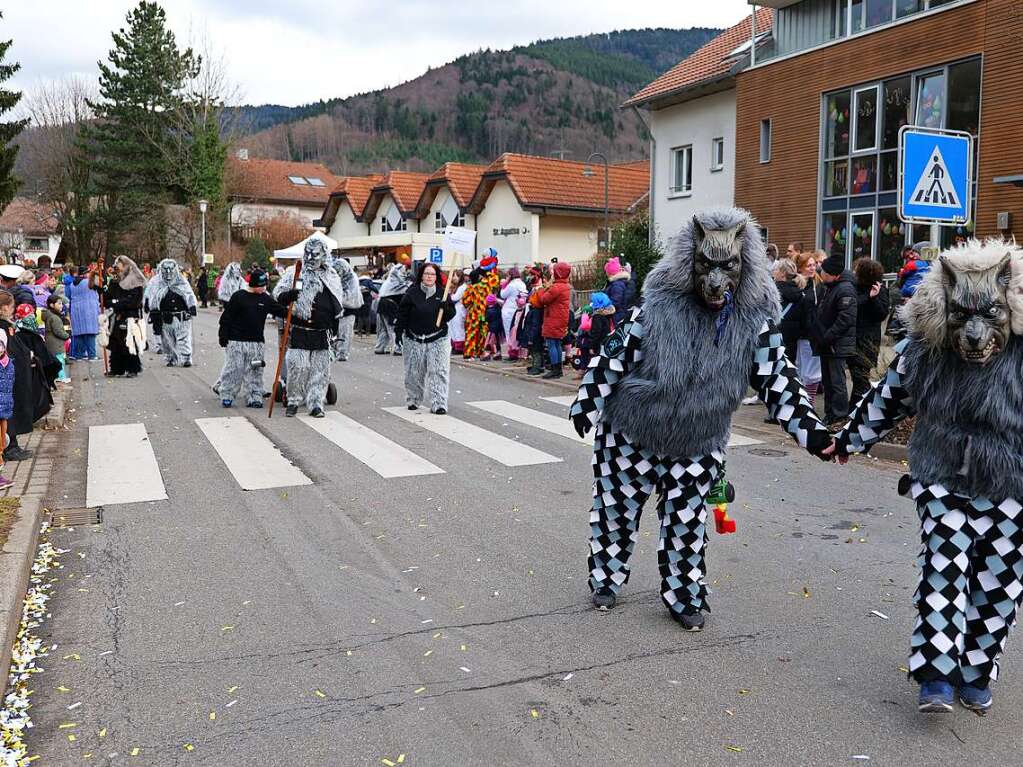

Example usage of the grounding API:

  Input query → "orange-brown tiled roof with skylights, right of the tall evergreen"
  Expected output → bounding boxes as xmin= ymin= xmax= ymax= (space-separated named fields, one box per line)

xmin=227 ymin=156 xmax=341 ymax=206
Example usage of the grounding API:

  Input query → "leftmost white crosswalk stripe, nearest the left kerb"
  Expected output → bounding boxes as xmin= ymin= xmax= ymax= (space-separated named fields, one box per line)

xmin=85 ymin=423 xmax=167 ymax=508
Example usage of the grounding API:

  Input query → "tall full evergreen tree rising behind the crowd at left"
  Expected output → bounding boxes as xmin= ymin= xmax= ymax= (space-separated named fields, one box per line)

xmin=85 ymin=0 xmax=198 ymax=258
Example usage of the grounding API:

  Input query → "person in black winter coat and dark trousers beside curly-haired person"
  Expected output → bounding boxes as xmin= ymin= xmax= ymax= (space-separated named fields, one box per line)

xmin=813 ymin=253 xmax=858 ymax=423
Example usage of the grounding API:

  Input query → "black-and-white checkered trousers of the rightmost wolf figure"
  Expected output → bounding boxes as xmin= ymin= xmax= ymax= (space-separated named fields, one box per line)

xmin=909 ymin=483 xmax=1023 ymax=686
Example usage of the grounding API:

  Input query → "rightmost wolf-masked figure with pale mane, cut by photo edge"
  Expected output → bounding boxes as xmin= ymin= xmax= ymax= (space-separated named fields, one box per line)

xmin=835 ymin=240 xmax=1023 ymax=713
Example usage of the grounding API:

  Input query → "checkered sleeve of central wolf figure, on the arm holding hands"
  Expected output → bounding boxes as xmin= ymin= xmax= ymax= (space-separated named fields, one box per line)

xmin=750 ymin=320 xmax=832 ymax=455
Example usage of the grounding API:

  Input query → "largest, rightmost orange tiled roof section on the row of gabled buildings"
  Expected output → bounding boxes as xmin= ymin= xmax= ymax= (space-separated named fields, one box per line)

xmin=470 ymin=154 xmax=650 ymax=214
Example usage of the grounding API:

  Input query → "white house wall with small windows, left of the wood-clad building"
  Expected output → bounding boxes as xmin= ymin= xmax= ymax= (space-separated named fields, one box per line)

xmin=650 ymin=89 xmax=736 ymax=243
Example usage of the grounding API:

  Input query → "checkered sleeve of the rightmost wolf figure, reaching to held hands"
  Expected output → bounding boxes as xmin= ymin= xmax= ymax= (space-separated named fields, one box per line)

xmin=835 ymin=339 xmax=917 ymax=454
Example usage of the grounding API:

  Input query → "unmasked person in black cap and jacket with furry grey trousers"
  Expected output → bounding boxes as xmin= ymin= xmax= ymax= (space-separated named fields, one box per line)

xmin=219 ymin=268 xmax=287 ymax=407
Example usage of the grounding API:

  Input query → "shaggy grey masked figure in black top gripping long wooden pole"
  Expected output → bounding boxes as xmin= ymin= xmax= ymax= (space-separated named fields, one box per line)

xmin=274 ymin=239 xmax=345 ymax=418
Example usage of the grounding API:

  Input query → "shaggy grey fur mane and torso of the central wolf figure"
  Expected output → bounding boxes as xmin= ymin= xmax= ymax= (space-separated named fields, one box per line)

xmin=604 ymin=208 xmax=781 ymax=458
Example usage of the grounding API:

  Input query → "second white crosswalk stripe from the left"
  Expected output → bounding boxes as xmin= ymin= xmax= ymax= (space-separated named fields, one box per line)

xmin=195 ymin=415 xmax=313 ymax=490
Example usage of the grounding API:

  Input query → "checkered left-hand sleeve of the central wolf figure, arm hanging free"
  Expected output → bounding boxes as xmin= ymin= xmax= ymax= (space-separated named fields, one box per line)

xmin=569 ymin=307 xmax=642 ymax=437
